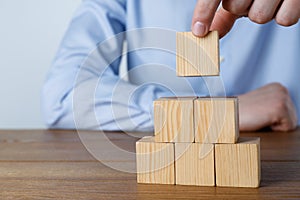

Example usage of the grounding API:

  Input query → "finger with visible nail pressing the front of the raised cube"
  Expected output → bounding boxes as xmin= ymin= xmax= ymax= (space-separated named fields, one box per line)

xmin=191 ymin=0 xmax=221 ymax=37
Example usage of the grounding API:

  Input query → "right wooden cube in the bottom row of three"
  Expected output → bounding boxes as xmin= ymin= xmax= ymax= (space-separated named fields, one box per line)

xmin=215 ymin=138 xmax=261 ymax=188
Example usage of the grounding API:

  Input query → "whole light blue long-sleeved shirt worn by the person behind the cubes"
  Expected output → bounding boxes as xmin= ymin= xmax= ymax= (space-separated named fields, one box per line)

xmin=42 ymin=0 xmax=300 ymax=131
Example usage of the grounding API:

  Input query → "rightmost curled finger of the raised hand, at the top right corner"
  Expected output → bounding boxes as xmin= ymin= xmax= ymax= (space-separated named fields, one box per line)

xmin=275 ymin=0 xmax=300 ymax=26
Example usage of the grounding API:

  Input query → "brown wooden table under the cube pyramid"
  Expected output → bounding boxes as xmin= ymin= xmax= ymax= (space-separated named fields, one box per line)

xmin=0 ymin=128 xmax=300 ymax=199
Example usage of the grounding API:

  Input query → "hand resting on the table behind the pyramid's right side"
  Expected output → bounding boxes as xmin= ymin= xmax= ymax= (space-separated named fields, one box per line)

xmin=239 ymin=83 xmax=297 ymax=131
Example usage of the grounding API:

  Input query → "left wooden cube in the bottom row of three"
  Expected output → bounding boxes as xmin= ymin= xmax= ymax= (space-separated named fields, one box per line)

xmin=136 ymin=137 xmax=175 ymax=184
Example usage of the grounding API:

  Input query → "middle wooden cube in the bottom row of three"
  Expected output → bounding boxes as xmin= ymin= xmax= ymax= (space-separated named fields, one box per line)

xmin=175 ymin=143 xmax=215 ymax=186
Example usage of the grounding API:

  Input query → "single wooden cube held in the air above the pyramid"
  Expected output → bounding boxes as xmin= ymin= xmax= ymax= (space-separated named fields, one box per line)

xmin=176 ymin=31 xmax=220 ymax=76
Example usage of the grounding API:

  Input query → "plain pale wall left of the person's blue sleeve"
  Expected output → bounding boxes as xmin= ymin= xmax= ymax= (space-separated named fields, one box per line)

xmin=0 ymin=0 xmax=81 ymax=129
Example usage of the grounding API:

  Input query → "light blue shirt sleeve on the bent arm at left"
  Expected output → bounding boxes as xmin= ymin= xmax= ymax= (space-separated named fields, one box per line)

xmin=42 ymin=0 xmax=170 ymax=131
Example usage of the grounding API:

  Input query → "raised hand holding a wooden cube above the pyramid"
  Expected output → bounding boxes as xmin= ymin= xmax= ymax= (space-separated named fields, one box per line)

xmin=192 ymin=0 xmax=300 ymax=37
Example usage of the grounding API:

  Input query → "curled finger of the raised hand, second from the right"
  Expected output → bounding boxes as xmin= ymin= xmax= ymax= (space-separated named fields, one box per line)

xmin=248 ymin=0 xmax=281 ymax=24
